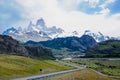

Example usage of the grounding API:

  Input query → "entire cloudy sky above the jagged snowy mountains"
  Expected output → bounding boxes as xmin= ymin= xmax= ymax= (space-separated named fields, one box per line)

xmin=0 ymin=0 xmax=120 ymax=36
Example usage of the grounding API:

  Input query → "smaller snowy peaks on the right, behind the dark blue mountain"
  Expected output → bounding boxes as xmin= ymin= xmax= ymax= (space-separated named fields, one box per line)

xmin=84 ymin=30 xmax=117 ymax=42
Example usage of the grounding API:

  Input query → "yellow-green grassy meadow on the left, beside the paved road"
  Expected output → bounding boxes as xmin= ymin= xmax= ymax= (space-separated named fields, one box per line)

xmin=0 ymin=55 xmax=71 ymax=80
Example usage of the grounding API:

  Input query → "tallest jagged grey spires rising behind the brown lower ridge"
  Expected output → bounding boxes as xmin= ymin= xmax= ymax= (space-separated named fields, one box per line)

xmin=26 ymin=18 xmax=64 ymax=38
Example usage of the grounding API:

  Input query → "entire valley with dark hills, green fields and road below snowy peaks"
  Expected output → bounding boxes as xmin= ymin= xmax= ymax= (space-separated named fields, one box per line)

xmin=0 ymin=32 xmax=120 ymax=80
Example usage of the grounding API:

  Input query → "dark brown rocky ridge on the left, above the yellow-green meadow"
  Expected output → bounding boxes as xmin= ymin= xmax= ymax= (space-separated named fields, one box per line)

xmin=0 ymin=35 xmax=54 ymax=59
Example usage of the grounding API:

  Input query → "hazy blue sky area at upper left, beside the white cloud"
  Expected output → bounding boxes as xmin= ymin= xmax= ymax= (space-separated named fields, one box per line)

xmin=0 ymin=0 xmax=22 ymax=30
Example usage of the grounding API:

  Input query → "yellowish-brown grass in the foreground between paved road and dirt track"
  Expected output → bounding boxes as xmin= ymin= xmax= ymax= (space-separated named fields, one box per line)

xmin=46 ymin=69 xmax=117 ymax=80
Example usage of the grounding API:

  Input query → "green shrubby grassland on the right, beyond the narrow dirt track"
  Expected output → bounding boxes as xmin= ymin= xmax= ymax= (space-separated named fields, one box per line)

xmin=66 ymin=59 xmax=120 ymax=76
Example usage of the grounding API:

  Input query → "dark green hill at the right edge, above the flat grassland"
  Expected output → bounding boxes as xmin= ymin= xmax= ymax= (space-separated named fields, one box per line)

xmin=86 ymin=40 xmax=120 ymax=57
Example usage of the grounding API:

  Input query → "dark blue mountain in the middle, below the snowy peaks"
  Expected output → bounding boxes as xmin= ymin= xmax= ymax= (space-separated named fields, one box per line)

xmin=26 ymin=35 xmax=96 ymax=52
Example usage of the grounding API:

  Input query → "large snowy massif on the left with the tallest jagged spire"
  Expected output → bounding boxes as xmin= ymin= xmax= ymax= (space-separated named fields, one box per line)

xmin=3 ymin=18 xmax=64 ymax=42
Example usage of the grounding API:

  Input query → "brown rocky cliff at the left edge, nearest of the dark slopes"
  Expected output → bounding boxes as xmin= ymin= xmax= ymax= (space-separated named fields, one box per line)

xmin=0 ymin=35 xmax=29 ymax=56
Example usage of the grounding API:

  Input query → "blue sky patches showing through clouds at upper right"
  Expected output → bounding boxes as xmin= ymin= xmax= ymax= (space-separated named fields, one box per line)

xmin=77 ymin=0 xmax=120 ymax=15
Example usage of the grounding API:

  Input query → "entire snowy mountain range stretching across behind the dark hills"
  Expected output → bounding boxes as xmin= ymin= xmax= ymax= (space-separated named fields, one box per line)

xmin=2 ymin=18 xmax=118 ymax=42
